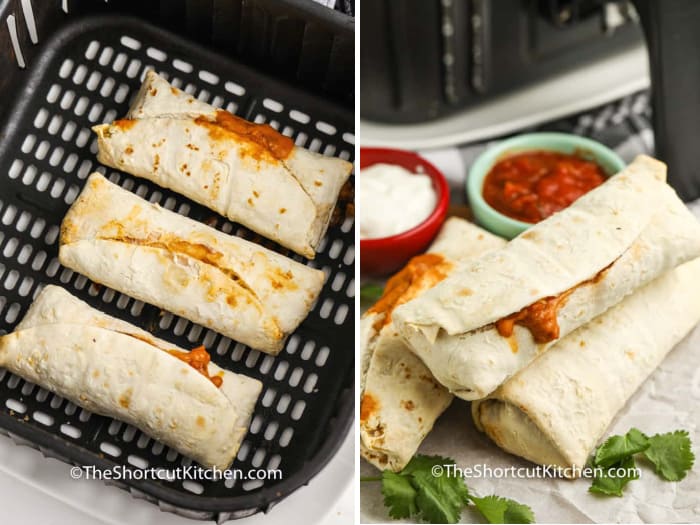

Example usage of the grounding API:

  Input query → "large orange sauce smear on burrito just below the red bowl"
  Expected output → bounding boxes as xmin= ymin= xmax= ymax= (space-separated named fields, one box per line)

xmin=368 ymin=253 xmax=452 ymax=330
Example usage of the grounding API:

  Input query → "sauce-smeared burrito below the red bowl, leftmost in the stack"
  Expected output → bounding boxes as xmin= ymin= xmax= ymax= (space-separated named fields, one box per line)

xmin=360 ymin=217 xmax=505 ymax=471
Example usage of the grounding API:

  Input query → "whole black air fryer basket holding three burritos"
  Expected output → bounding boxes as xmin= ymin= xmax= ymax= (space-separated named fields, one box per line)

xmin=0 ymin=0 xmax=354 ymax=521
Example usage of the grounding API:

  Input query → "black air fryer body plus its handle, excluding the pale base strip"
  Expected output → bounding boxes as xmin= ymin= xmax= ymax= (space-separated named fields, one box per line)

xmin=360 ymin=0 xmax=700 ymax=200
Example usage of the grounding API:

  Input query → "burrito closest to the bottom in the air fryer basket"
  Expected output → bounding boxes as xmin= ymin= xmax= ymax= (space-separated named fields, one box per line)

xmin=0 ymin=286 xmax=262 ymax=469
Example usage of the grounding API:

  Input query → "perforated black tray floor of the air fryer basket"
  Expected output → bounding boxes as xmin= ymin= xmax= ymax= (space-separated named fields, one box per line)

xmin=0 ymin=18 xmax=355 ymax=505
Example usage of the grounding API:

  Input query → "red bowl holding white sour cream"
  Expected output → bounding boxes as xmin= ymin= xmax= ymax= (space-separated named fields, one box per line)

xmin=360 ymin=148 xmax=450 ymax=276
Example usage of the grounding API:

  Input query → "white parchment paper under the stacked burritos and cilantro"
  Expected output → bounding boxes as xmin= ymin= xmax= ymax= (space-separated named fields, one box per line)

xmin=360 ymin=327 xmax=700 ymax=523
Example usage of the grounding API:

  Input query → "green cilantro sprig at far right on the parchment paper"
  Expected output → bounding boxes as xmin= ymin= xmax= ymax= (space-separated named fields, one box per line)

xmin=588 ymin=428 xmax=695 ymax=497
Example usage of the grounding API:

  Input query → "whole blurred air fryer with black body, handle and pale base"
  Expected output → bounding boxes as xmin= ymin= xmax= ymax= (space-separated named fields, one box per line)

xmin=360 ymin=0 xmax=700 ymax=200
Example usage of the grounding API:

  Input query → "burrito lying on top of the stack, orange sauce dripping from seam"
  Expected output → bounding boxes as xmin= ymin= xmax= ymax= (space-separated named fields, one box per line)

xmin=393 ymin=157 xmax=700 ymax=400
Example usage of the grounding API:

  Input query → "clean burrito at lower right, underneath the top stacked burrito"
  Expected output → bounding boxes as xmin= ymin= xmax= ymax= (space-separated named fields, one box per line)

xmin=472 ymin=259 xmax=700 ymax=474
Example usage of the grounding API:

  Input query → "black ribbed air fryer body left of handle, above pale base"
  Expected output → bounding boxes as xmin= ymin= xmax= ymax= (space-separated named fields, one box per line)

xmin=360 ymin=0 xmax=642 ymax=123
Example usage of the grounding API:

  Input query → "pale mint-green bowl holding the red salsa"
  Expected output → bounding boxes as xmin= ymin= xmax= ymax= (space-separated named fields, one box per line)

xmin=467 ymin=133 xmax=626 ymax=239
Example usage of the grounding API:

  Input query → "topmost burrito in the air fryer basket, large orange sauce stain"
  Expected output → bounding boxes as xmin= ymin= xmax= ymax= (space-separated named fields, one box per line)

xmin=93 ymin=71 xmax=352 ymax=258
